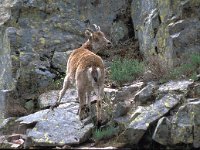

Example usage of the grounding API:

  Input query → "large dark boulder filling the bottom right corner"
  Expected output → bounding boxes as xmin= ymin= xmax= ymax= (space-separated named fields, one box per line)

xmin=153 ymin=99 xmax=200 ymax=148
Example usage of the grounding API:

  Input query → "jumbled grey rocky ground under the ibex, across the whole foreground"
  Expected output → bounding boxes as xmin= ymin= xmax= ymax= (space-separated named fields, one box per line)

xmin=0 ymin=77 xmax=200 ymax=148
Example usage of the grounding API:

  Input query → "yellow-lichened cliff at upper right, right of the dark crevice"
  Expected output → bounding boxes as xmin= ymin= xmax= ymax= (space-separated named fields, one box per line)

xmin=131 ymin=0 xmax=200 ymax=66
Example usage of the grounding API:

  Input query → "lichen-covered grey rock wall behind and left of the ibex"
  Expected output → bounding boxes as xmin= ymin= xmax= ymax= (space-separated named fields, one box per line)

xmin=0 ymin=0 xmax=134 ymax=114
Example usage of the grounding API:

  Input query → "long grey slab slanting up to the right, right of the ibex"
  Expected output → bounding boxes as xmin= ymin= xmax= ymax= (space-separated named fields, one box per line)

xmin=119 ymin=94 xmax=181 ymax=144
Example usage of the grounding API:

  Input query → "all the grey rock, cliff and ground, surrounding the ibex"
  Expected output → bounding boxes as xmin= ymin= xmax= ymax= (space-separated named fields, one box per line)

xmin=0 ymin=0 xmax=200 ymax=149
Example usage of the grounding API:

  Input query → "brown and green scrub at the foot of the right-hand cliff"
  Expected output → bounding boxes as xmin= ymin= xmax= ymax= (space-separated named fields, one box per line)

xmin=145 ymin=53 xmax=200 ymax=83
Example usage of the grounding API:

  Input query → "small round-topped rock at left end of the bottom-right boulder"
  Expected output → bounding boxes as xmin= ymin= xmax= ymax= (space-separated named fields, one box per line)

xmin=152 ymin=117 xmax=172 ymax=145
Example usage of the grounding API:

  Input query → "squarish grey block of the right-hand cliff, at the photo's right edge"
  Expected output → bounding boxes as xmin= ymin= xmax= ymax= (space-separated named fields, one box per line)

xmin=168 ymin=18 xmax=200 ymax=64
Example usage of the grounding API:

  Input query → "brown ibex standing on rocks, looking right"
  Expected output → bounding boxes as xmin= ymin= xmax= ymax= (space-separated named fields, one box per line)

xmin=52 ymin=24 xmax=112 ymax=122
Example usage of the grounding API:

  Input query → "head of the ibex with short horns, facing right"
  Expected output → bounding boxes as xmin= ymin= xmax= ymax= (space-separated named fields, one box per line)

xmin=85 ymin=24 xmax=112 ymax=52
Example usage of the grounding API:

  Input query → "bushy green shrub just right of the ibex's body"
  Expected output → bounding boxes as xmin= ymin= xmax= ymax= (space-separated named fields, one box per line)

xmin=110 ymin=58 xmax=144 ymax=84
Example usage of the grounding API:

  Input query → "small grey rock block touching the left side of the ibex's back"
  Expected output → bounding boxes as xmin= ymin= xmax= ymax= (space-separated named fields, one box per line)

xmin=52 ymin=51 xmax=72 ymax=73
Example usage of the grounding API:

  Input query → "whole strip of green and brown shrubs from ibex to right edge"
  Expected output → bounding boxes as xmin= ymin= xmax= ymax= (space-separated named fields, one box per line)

xmin=110 ymin=53 xmax=200 ymax=85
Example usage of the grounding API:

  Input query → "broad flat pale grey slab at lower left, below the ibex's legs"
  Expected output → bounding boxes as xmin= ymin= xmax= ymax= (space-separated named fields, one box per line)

xmin=17 ymin=102 xmax=94 ymax=147
